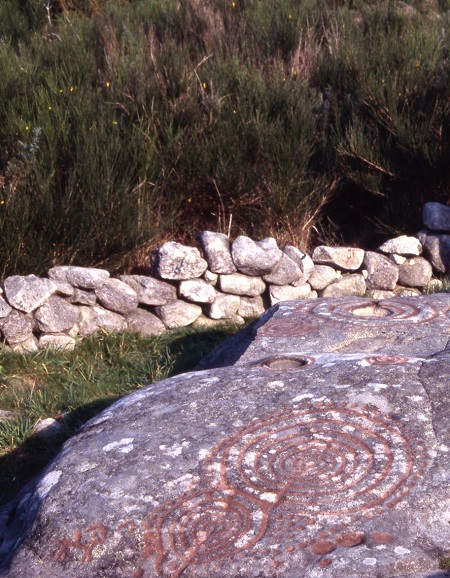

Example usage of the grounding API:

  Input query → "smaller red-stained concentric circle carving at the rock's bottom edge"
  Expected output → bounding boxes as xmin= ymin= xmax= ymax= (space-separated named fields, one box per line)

xmin=159 ymin=489 xmax=267 ymax=564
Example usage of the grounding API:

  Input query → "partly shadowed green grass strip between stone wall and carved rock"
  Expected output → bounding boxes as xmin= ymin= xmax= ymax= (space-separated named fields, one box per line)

xmin=0 ymin=327 xmax=241 ymax=505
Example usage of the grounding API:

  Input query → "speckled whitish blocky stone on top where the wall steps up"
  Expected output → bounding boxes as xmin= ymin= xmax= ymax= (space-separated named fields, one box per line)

xmin=152 ymin=242 xmax=208 ymax=280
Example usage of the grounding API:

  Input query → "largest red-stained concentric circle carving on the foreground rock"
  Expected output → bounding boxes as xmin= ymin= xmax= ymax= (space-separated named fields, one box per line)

xmin=210 ymin=405 xmax=423 ymax=515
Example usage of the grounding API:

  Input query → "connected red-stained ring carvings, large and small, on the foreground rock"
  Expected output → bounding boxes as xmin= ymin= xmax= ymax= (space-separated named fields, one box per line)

xmin=55 ymin=403 xmax=426 ymax=578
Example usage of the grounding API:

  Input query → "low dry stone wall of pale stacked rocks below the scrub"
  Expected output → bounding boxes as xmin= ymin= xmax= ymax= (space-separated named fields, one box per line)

xmin=0 ymin=203 xmax=450 ymax=352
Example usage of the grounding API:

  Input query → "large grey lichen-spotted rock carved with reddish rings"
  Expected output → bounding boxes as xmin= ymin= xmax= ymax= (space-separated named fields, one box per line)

xmin=0 ymin=296 xmax=450 ymax=578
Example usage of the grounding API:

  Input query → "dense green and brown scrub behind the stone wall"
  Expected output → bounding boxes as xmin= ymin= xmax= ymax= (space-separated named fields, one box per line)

xmin=0 ymin=0 xmax=450 ymax=277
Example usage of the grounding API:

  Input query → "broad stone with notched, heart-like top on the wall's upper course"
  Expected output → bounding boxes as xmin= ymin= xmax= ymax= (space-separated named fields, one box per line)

xmin=231 ymin=235 xmax=282 ymax=277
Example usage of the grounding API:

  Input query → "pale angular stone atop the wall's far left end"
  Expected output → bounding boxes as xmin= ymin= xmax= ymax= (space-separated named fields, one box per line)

xmin=3 ymin=275 xmax=57 ymax=313
